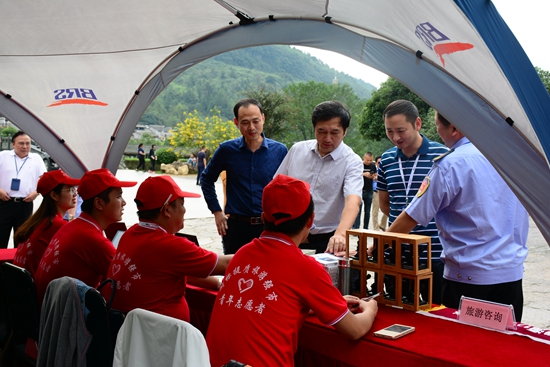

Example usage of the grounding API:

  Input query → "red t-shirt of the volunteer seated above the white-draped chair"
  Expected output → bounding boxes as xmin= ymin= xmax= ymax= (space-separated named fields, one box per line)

xmin=105 ymin=221 xmax=218 ymax=322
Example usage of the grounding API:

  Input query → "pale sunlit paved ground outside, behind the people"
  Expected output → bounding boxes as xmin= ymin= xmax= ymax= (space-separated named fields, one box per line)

xmin=10 ymin=170 xmax=550 ymax=329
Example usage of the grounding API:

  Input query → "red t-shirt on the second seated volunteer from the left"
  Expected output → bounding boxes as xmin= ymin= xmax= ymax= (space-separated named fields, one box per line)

xmin=35 ymin=213 xmax=116 ymax=302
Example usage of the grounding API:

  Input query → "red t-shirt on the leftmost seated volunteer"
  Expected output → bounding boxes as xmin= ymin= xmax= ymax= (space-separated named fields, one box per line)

xmin=13 ymin=213 xmax=67 ymax=278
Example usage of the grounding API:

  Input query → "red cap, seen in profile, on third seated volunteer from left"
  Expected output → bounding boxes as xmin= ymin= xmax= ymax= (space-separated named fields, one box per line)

xmin=134 ymin=175 xmax=201 ymax=211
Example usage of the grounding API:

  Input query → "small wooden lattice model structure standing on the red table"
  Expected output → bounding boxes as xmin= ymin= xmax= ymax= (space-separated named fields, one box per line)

xmin=346 ymin=229 xmax=432 ymax=311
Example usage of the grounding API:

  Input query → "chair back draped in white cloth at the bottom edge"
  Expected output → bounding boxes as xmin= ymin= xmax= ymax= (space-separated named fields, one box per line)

xmin=113 ymin=308 xmax=210 ymax=367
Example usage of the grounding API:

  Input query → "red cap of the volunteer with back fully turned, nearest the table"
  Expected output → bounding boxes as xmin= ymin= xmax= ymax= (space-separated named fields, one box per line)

xmin=262 ymin=174 xmax=311 ymax=225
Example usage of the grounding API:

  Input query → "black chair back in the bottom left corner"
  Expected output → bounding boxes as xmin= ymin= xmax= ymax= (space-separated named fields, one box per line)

xmin=2 ymin=263 xmax=40 ymax=366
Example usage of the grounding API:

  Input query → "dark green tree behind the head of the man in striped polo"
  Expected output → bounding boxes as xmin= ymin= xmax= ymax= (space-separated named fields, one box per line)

xmin=359 ymin=78 xmax=437 ymax=140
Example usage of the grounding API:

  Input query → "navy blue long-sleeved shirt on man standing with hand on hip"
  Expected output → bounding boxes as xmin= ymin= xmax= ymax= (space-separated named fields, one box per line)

xmin=201 ymin=133 xmax=288 ymax=217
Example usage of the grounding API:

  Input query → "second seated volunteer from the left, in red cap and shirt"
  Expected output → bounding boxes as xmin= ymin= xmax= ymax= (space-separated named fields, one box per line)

xmin=35 ymin=168 xmax=137 ymax=301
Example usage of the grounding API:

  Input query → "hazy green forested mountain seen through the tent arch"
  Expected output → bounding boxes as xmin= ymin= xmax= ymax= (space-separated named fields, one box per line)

xmin=140 ymin=45 xmax=376 ymax=126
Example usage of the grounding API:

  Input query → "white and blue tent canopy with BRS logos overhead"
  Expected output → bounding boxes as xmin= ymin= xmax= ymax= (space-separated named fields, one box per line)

xmin=0 ymin=0 xmax=550 ymax=246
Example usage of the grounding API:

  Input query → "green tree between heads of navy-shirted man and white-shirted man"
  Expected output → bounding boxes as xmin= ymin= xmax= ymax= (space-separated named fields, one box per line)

xmin=244 ymin=85 xmax=289 ymax=140
